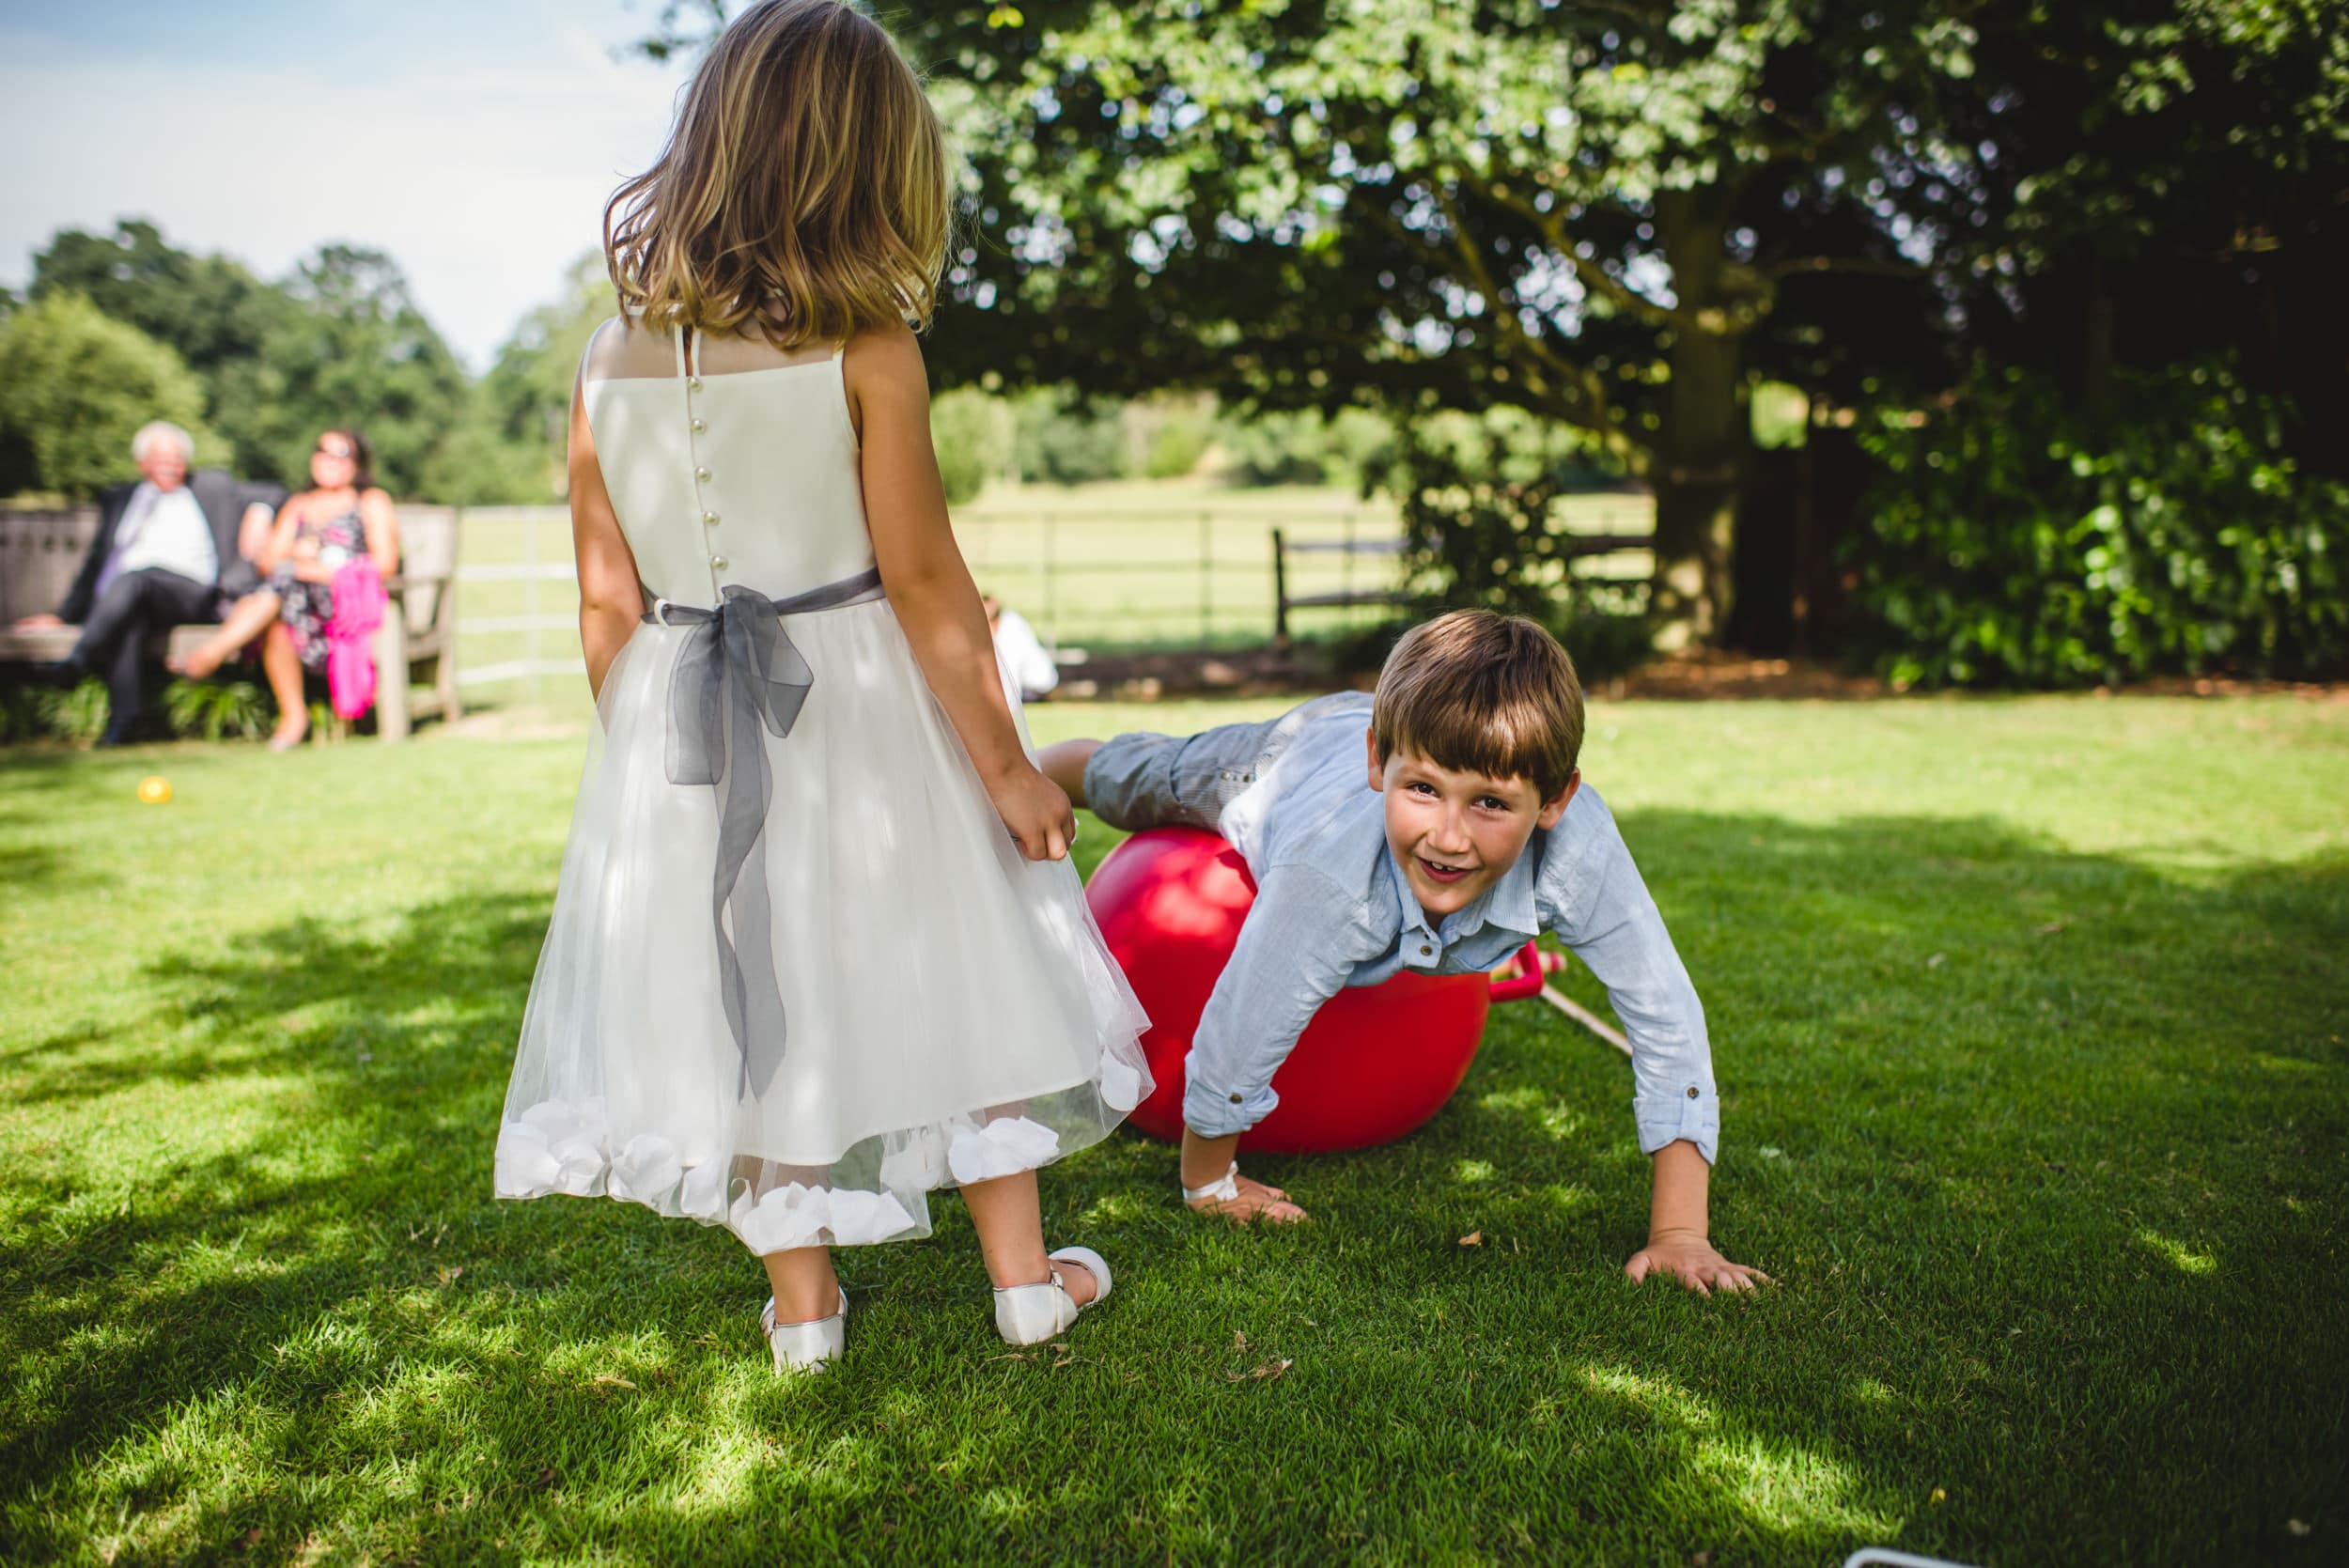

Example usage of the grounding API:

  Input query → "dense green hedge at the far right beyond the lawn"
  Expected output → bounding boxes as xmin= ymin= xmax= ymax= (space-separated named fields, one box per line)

xmin=1849 ymin=364 xmax=2349 ymax=686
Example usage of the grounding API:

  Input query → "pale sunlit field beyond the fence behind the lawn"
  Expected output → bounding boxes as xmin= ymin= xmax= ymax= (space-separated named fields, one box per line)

xmin=443 ymin=481 xmax=1654 ymax=694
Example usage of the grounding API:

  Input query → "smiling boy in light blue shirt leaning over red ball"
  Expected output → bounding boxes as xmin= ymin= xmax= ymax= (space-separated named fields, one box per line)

xmin=1043 ymin=611 xmax=1766 ymax=1291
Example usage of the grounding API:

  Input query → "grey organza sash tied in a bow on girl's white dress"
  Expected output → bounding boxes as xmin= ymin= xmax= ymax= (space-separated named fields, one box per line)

xmin=644 ymin=568 xmax=881 ymax=1096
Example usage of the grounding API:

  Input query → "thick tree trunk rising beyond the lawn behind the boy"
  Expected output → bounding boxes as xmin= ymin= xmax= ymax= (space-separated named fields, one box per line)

xmin=1649 ymin=190 xmax=1752 ymax=653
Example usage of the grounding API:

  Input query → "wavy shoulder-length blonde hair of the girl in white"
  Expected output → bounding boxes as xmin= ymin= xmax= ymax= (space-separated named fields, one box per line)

xmin=604 ymin=0 xmax=952 ymax=349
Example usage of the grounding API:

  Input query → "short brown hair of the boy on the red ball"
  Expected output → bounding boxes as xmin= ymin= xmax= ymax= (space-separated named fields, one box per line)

xmin=1370 ymin=611 xmax=1583 ymax=800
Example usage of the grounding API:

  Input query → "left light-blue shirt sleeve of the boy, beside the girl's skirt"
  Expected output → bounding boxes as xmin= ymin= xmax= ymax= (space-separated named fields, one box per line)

xmin=1182 ymin=866 xmax=1370 ymax=1139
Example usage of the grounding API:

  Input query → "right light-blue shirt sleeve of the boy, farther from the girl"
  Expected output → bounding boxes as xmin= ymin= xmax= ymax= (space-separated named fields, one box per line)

xmin=1553 ymin=800 xmax=1722 ymax=1164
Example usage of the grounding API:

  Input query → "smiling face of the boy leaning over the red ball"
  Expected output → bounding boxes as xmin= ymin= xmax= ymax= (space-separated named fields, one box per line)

xmin=1370 ymin=735 xmax=1583 ymax=920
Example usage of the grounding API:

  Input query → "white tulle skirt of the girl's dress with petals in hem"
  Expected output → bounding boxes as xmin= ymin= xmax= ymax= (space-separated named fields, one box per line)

xmin=496 ymin=601 xmax=1151 ymax=1253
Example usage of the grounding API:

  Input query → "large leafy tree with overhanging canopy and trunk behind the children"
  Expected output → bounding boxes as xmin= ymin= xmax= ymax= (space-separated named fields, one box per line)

xmin=646 ymin=0 xmax=2349 ymax=636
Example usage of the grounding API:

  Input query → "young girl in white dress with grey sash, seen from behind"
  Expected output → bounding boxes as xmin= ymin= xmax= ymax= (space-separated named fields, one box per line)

xmin=498 ymin=0 xmax=1151 ymax=1371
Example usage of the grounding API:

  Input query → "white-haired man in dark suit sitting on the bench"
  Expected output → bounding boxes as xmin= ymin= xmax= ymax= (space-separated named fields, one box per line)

xmin=17 ymin=420 xmax=285 ymax=747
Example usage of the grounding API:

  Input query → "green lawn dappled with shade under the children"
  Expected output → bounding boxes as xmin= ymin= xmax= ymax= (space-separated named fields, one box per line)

xmin=0 ymin=700 xmax=2349 ymax=1566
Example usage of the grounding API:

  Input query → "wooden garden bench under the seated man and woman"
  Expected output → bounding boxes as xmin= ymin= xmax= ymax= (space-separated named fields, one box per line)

xmin=0 ymin=507 xmax=463 ymax=739
